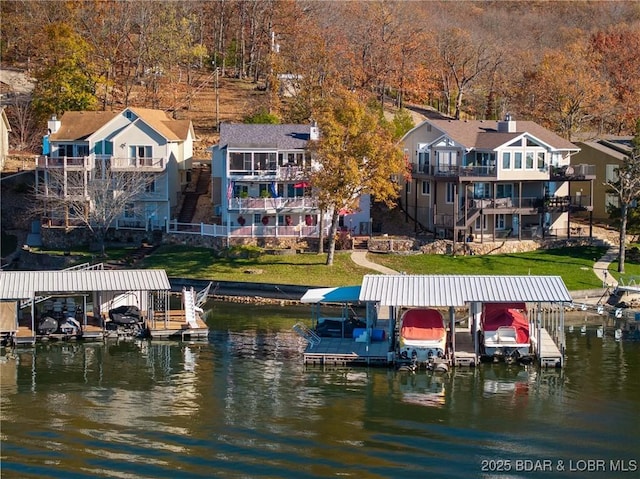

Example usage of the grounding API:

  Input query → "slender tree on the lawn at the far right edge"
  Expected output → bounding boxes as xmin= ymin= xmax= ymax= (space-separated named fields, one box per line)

xmin=605 ymin=120 xmax=640 ymax=274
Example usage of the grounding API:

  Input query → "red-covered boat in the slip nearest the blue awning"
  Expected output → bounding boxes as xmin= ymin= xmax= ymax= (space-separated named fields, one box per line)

xmin=399 ymin=308 xmax=447 ymax=362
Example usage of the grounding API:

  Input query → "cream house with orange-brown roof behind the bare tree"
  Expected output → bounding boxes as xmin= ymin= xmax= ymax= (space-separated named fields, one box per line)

xmin=36 ymin=108 xmax=195 ymax=229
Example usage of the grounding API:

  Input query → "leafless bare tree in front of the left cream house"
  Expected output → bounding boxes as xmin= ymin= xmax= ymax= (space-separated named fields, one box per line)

xmin=36 ymin=165 xmax=158 ymax=256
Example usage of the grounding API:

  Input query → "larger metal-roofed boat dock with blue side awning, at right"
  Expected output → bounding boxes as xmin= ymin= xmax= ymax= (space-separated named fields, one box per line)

xmin=294 ymin=275 xmax=572 ymax=368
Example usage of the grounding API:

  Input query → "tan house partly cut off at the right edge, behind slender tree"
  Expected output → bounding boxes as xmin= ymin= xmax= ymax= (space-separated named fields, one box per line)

xmin=571 ymin=136 xmax=633 ymax=221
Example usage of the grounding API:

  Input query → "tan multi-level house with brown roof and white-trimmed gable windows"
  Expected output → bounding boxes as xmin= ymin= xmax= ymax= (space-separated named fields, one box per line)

xmin=401 ymin=116 xmax=595 ymax=241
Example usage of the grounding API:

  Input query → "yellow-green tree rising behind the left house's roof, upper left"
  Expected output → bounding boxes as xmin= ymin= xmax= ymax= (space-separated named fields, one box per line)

xmin=33 ymin=23 xmax=97 ymax=119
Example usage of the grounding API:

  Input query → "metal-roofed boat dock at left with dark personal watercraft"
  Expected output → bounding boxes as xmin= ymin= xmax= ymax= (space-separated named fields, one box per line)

xmin=0 ymin=265 xmax=211 ymax=346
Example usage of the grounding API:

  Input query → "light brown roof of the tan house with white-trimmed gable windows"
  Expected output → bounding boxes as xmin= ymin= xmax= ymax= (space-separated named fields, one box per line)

xmin=423 ymin=120 xmax=580 ymax=151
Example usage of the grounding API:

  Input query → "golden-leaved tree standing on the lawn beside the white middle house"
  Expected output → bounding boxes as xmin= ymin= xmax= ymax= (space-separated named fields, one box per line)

xmin=311 ymin=91 xmax=406 ymax=265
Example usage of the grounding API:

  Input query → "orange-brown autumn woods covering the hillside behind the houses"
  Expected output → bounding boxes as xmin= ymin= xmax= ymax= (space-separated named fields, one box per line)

xmin=0 ymin=0 xmax=640 ymax=158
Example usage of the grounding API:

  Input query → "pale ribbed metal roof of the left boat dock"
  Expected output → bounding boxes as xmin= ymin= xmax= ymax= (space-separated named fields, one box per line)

xmin=0 ymin=269 xmax=171 ymax=300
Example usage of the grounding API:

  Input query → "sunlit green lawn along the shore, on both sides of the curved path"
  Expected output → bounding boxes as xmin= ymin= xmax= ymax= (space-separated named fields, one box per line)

xmin=134 ymin=245 xmax=616 ymax=291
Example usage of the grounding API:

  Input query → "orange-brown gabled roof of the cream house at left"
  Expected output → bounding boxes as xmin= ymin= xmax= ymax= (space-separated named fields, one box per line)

xmin=49 ymin=108 xmax=192 ymax=141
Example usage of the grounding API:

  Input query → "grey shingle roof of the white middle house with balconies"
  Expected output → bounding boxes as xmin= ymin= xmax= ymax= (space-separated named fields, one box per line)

xmin=219 ymin=123 xmax=311 ymax=150
